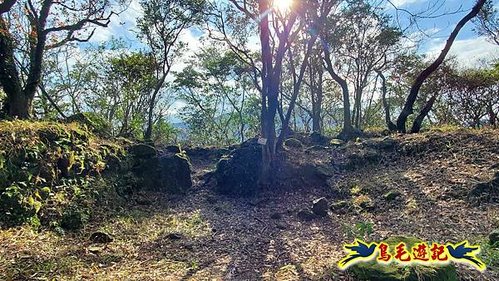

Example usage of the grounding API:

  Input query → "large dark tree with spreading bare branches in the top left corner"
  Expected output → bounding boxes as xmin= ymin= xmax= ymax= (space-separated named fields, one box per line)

xmin=0 ymin=0 xmax=123 ymax=119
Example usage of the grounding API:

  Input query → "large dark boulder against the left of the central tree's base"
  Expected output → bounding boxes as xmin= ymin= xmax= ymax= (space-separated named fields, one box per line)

xmin=215 ymin=139 xmax=262 ymax=197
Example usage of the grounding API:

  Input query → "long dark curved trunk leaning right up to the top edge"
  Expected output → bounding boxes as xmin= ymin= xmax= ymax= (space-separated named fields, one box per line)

xmin=397 ymin=0 xmax=486 ymax=133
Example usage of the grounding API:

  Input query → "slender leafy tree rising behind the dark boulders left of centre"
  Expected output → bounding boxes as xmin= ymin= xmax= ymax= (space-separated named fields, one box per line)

xmin=138 ymin=0 xmax=206 ymax=140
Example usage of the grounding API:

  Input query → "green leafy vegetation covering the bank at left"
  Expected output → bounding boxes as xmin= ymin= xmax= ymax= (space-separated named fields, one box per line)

xmin=0 ymin=121 xmax=124 ymax=228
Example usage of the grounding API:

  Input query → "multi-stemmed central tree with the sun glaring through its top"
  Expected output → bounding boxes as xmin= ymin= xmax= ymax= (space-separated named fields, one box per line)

xmin=230 ymin=0 xmax=337 ymax=182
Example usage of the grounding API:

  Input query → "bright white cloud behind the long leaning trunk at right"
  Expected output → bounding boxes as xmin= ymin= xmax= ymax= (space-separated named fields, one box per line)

xmin=427 ymin=37 xmax=499 ymax=67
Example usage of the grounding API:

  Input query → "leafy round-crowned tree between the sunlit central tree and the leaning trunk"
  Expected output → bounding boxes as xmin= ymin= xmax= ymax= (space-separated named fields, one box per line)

xmin=323 ymin=1 xmax=401 ymax=138
